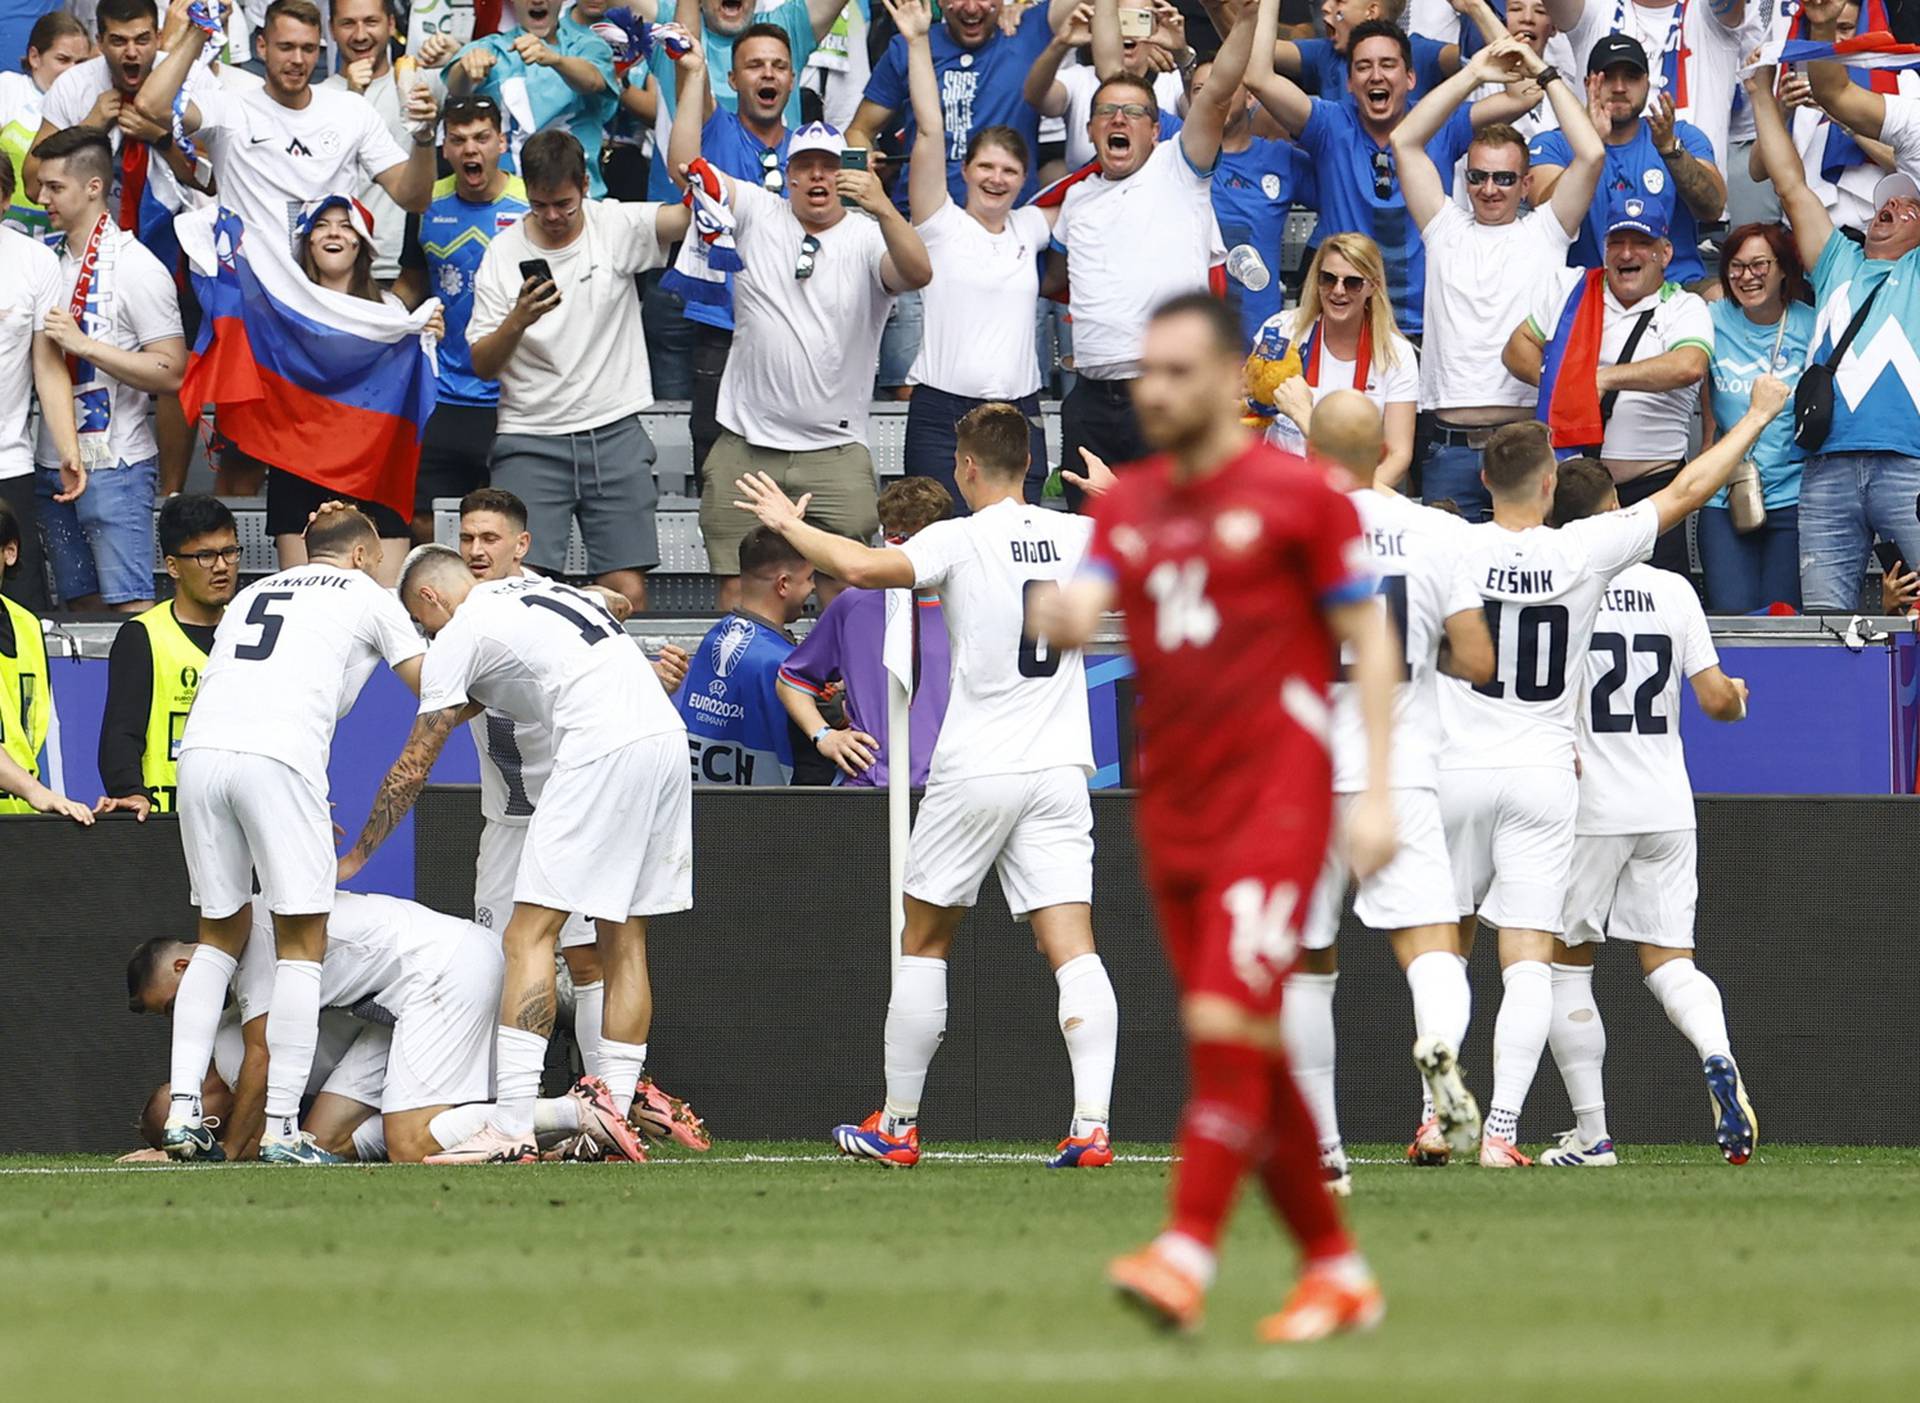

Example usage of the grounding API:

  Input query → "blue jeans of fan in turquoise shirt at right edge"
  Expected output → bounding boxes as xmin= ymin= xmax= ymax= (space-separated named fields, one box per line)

xmin=1799 ymin=453 xmax=1920 ymax=614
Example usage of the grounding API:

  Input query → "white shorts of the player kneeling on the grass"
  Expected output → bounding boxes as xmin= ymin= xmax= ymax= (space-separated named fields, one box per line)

xmin=380 ymin=925 xmax=505 ymax=1115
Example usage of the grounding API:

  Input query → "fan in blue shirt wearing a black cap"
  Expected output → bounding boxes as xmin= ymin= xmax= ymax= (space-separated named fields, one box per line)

xmin=1526 ymin=35 xmax=1726 ymax=284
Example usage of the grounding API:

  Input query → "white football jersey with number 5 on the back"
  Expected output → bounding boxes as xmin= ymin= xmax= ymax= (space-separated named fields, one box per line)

xmin=180 ymin=564 xmax=426 ymax=795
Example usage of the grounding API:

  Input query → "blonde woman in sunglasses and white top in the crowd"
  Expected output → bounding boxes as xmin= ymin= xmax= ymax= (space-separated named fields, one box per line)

xmin=1261 ymin=234 xmax=1421 ymax=487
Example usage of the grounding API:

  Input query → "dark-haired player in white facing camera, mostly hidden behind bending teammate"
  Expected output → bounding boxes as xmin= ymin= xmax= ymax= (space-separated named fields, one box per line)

xmin=461 ymin=487 xmax=712 ymax=1150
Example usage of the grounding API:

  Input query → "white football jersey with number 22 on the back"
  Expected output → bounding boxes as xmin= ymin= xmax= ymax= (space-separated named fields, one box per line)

xmin=1574 ymin=564 xmax=1720 ymax=835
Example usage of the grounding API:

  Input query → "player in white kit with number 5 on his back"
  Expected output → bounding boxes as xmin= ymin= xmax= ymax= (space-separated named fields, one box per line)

xmin=163 ymin=503 xmax=426 ymax=1163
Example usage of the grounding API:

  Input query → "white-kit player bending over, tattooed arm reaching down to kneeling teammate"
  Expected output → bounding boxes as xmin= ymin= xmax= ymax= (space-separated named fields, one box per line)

xmin=340 ymin=545 xmax=693 ymax=1163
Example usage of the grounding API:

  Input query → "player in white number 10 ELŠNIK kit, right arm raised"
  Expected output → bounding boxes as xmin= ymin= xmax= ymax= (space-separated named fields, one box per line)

xmin=1440 ymin=376 xmax=1788 ymax=1169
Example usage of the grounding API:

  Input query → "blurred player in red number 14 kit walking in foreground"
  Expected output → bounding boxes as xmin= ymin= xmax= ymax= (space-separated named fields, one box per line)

xmin=1029 ymin=296 xmax=1396 ymax=1342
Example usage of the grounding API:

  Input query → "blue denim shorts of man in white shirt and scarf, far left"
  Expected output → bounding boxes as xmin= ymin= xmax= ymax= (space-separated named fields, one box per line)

xmin=35 ymin=459 xmax=159 ymax=605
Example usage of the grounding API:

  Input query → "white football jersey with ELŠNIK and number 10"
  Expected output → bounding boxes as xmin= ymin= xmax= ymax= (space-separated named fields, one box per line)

xmin=1440 ymin=501 xmax=1661 ymax=770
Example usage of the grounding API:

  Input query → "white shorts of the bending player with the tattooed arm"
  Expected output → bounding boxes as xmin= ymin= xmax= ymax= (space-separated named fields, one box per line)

xmin=513 ymin=731 xmax=693 ymax=921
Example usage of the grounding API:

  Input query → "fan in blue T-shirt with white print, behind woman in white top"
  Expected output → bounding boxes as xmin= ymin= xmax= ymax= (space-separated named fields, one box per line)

xmin=847 ymin=0 xmax=1081 ymax=209
